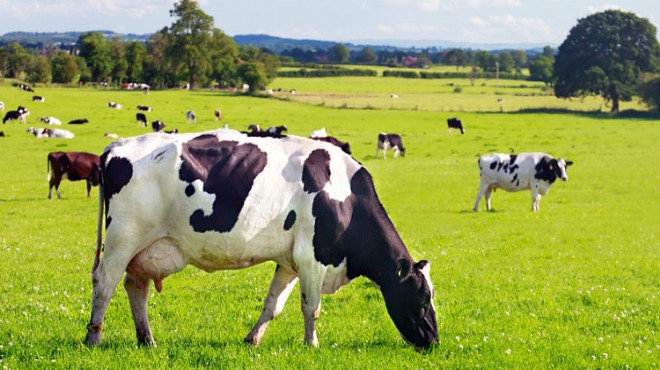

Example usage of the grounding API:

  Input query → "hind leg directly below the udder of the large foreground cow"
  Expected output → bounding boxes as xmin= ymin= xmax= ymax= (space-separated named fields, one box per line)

xmin=124 ymin=274 xmax=156 ymax=347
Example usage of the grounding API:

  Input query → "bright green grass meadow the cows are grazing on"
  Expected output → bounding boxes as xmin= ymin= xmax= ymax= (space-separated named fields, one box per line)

xmin=0 ymin=78 xmax=660 ymax=369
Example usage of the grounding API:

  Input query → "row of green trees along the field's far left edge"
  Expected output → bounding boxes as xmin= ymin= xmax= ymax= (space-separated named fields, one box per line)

xmin=0 ymin=0 xmax=279 ymax=89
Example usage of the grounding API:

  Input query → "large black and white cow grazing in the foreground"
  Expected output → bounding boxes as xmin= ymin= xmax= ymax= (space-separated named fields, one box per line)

xmin=85 ymin=129 xmax=438 ymax=348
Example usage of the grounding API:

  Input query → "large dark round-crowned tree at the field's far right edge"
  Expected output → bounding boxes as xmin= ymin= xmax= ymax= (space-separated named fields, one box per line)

xmin=554 ymin=10 xmax=660 ymax=113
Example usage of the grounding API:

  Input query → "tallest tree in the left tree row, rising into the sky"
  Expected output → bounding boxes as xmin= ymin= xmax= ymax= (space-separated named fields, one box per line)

xmin=166 ymin=0 xmax=213 ymax=89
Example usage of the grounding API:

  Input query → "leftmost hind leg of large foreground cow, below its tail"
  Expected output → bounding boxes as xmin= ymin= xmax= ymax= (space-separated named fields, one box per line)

xmin=85 ymin=255 xmax=127 ymax=346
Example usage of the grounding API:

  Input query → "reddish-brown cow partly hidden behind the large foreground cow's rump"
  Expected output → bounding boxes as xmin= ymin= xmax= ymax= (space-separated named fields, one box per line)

xmin=47 ymin=152 xmax=99 ymax=199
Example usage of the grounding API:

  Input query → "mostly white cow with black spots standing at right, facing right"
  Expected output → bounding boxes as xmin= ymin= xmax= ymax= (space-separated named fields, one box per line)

xmin=473 ymin=152 xmax=573 ymax=212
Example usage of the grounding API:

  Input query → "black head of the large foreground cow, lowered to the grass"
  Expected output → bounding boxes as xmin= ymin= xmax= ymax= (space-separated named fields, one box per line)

xmin=381 ymin=259 xmax=438 ymax=349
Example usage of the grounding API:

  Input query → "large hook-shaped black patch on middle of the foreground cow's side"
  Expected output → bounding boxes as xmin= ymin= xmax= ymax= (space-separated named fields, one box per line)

xmin=179 ymin=135 xmax=268 ymax=232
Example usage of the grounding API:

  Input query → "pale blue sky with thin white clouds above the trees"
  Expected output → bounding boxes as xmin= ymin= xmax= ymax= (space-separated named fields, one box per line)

xmin=0 ymin=0 xmax=660 ymax=47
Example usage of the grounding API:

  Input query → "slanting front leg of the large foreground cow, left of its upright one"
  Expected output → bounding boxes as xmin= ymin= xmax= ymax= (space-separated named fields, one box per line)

xmin=245 ymin=265 xmax=298 ymax=347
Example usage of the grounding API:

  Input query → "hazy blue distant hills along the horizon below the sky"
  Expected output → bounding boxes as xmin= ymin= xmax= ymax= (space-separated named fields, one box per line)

xmin=0 ymin=30 xmax=554 ymax=54
